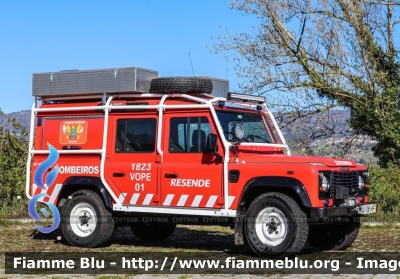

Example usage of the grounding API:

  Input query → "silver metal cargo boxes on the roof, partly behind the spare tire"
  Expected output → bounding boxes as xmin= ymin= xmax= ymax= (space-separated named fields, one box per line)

xmin=32 ymin=67 xmax=229 ymax=101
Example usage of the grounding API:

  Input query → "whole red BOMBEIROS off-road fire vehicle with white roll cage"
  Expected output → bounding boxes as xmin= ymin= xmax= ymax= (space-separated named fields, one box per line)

xmin=26 ymin=67 xmax=376 ymax=256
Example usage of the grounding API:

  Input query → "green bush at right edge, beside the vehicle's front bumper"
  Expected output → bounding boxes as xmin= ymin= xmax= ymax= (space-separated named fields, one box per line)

xmin=369 ymin=167 xmax=400 ymax=222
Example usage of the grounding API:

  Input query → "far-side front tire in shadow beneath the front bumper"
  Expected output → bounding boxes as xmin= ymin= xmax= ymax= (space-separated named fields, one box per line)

xmin=308 ymin=218 xmax=360 ymax=250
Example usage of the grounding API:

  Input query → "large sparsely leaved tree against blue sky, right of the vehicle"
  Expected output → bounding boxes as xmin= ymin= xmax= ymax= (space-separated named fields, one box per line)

xmin=215 ymin=0 xmax=400 ymax=167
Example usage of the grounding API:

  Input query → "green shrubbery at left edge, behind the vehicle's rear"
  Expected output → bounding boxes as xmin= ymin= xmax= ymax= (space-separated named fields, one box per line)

xmin=0 ymin=110 xmax=28 ymax=216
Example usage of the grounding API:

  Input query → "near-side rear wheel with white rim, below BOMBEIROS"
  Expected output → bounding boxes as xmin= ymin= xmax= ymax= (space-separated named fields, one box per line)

xmin=61 ymin=190 xmax=114 ymax=248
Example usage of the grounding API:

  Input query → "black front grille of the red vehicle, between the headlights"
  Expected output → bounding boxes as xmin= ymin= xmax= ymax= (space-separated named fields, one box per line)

xmin=331 ymin=171 xmax=358 ymax=199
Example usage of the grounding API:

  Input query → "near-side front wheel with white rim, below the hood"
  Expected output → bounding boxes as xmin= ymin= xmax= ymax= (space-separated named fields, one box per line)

xmin=245 ymin=192 xmax=308 ymax=258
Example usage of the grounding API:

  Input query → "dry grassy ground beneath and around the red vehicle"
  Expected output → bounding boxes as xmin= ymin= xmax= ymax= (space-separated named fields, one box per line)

xmin=0 ymin=226 xmax=400 ymax=279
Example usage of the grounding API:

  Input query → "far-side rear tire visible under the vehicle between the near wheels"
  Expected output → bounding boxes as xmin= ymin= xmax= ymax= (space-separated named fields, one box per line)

xmin=130 ymin=222 xmax=176 ymax=241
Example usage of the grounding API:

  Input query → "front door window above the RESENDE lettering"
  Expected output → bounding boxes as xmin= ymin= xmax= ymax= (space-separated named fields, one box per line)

xmin=168 ymin=117 xmax=212 ymax=153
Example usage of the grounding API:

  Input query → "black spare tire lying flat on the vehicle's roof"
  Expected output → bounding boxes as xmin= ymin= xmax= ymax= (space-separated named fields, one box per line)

xmin=150 ymin=77 xmax=213 ymax=93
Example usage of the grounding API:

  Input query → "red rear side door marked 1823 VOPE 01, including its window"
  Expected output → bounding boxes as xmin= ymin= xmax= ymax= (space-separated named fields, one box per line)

xmin=105 ymin=116 xmax=158 ymax=206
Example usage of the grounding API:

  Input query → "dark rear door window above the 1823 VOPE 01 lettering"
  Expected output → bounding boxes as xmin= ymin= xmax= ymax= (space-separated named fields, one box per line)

xmin=115 ymin=118 xmax=156 ymax=153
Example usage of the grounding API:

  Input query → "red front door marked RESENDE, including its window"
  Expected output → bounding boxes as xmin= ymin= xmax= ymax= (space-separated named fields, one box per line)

xmin=160 ymin=113 xmax=223 ymax=209
